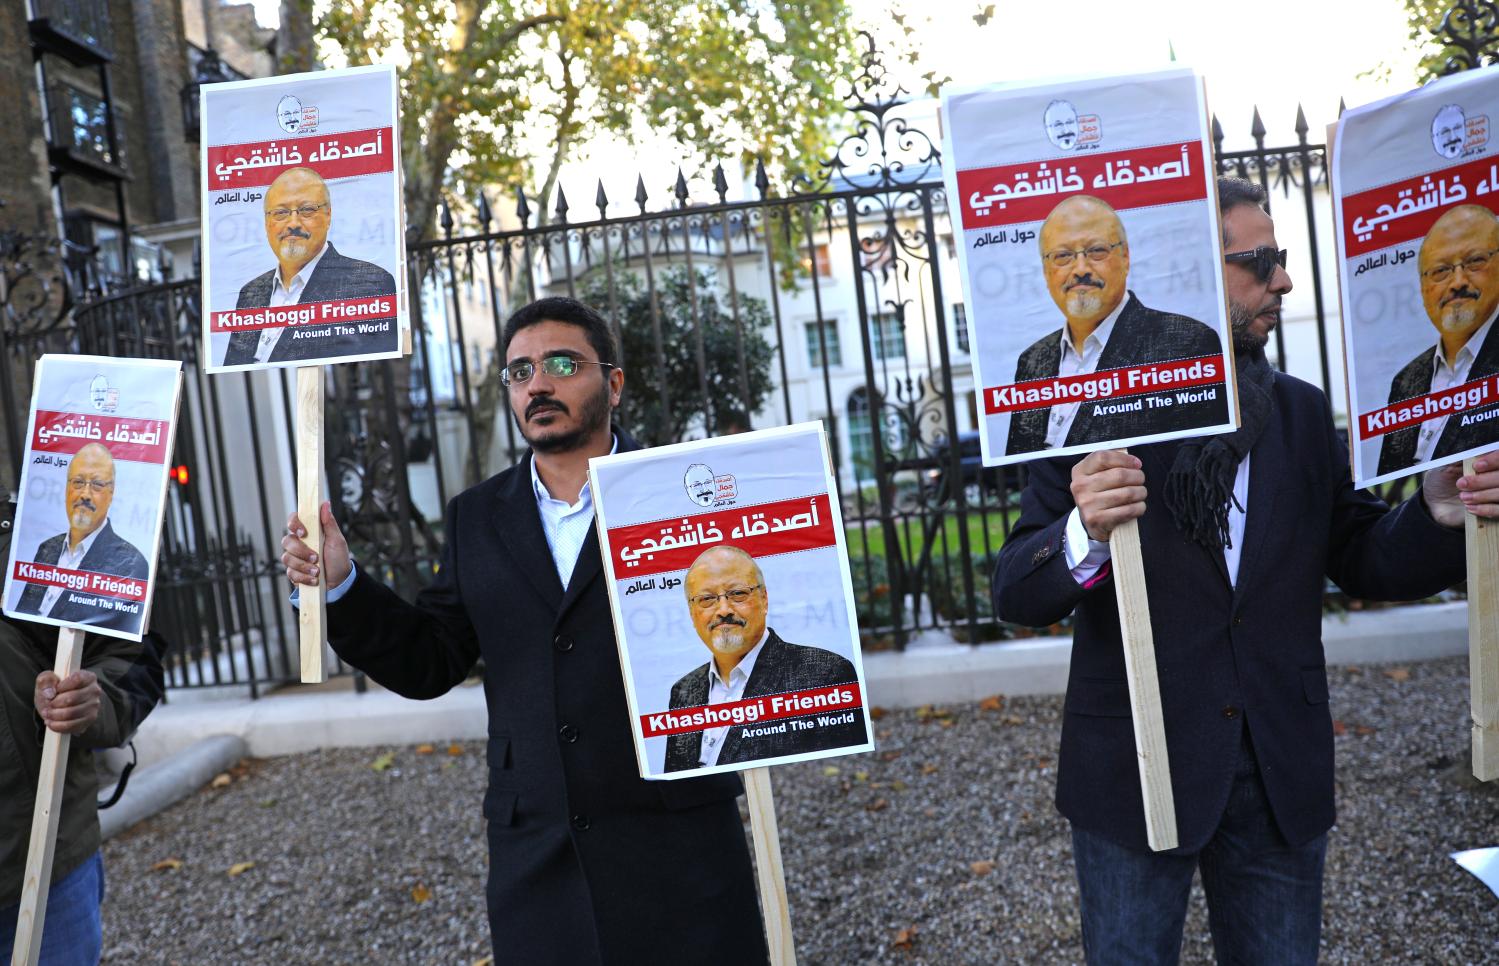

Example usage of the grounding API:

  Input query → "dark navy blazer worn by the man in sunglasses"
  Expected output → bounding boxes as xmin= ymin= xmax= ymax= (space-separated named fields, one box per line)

xmin=994 ymin=374 xmax=1465 ymax=852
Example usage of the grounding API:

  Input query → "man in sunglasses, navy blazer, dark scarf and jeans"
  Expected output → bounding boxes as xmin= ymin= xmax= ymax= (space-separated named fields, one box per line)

xmin=994 ymin=179 xmax=1499 ymax=966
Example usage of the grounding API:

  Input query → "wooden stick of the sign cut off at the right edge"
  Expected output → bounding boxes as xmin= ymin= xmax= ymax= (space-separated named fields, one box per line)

xmin=1463 ymin=459 xmax=1499 ymax=782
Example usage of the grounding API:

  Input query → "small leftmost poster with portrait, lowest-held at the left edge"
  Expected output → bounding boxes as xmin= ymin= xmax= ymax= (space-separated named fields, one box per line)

xmin=4 ymin=356 xmax=181 ymax=641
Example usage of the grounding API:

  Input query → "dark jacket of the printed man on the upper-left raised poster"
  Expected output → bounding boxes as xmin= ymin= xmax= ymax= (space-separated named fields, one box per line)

xmin=223 ymin=242 xmax=400 ymax=366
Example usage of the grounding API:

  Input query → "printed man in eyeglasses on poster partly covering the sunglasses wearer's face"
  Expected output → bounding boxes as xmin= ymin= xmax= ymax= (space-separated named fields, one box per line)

xmin=1004 ymin=195 xmax=1228 ymax=453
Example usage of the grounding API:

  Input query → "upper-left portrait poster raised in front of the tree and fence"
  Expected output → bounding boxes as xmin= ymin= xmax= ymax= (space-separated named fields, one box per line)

xmin=201 ymin=66 xmax=408 ymax=372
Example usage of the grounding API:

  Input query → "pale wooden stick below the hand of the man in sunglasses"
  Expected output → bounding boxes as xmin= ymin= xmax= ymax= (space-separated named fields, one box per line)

xmin=1109 ymin=521 xmax=1177 ymax=852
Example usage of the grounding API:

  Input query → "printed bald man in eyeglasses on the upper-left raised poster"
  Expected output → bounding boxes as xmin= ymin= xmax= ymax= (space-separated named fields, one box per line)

xmin=223 ymin=168 xmax=400 ymax=366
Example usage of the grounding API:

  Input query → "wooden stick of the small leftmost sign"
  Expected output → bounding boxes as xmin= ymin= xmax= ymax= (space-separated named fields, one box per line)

xmin=10 ymin=627 xmax=84 ymax=966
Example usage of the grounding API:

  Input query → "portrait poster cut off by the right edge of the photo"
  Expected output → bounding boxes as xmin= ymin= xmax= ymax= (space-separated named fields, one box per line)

xmin=1333 ymin=68 xmax=1499 ymax=486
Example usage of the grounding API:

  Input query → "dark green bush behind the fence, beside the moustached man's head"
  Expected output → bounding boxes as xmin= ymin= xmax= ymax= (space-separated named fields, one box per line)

xmin=579 ymin=266 xmax=773 ymax=446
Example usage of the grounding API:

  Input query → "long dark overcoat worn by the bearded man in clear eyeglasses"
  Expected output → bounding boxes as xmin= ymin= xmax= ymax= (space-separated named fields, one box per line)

xmin=328 ymin=431 xmax=767 ymax=966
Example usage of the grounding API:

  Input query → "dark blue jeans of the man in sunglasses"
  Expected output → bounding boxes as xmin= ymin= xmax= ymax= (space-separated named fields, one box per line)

xmin=1072 ymin=729 xmax=1327 ymax=966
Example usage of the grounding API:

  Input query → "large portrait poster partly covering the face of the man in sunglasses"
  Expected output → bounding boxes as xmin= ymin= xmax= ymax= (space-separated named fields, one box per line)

xmin=941 ymin=69 xmax=1238 ymax=465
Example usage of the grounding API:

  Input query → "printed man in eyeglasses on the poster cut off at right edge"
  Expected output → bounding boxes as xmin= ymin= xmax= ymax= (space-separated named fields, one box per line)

xmin=1379 ymin=204 xmax=1499 ymax=474
